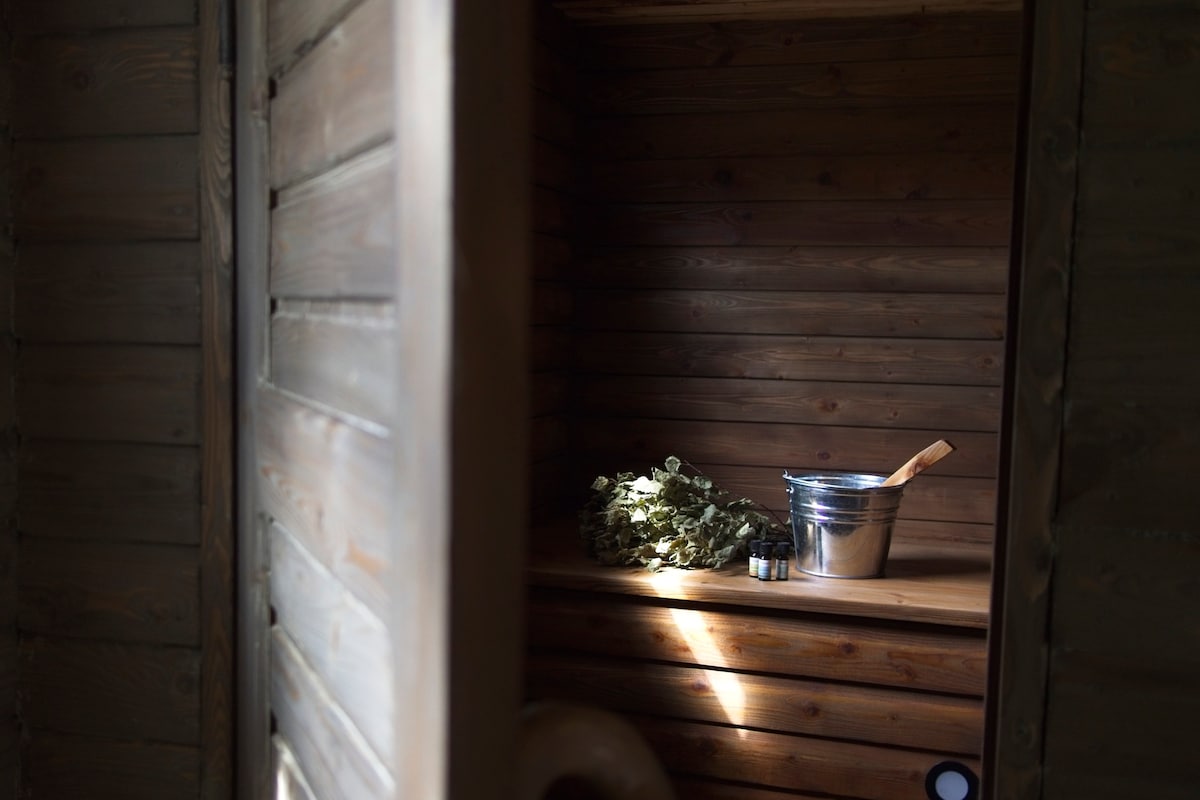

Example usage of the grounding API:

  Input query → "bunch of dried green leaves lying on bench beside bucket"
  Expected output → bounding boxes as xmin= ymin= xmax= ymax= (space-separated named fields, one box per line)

xmin=580 ymin=456 xmax=782 ymax=572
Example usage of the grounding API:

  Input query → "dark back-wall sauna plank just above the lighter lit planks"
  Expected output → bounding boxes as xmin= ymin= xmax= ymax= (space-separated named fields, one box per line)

xmin=586 ymin=200 xmax=1010 ymax=247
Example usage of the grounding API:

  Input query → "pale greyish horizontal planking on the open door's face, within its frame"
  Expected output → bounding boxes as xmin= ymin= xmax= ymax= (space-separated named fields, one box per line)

xmin=255 ymin=0 xmax=401 ymax=800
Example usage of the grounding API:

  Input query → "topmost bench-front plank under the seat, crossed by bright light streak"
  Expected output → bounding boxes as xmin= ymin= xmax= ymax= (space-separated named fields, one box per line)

xmin=529 ymin=587 xmax=986 ymax=697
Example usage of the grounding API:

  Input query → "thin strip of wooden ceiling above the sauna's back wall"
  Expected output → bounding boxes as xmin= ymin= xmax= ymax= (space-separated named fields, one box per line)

xmin=551 ymin=0 xmax=1022 ymax=25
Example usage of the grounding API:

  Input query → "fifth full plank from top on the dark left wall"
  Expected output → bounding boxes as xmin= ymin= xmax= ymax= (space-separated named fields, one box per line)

xmin=19 ymin=441 xmax=200 ymax=545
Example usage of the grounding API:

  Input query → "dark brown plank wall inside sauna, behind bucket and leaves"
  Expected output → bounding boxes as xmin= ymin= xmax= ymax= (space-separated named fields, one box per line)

xmin=533 ymin=4 xmax=1019 ymax=546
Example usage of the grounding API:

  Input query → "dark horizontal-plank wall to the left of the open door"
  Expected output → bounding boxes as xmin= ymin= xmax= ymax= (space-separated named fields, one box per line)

xmin=4 ymin=0 xmax=233 ymax=798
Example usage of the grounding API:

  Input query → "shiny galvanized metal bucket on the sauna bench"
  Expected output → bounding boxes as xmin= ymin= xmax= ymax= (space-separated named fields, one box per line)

xmin=784 ymin=473 xmax=904 ymax=578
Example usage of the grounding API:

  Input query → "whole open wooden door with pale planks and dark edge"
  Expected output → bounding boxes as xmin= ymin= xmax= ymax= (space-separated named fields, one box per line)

xmin=236 ymin=0 xmax=528 ymax=800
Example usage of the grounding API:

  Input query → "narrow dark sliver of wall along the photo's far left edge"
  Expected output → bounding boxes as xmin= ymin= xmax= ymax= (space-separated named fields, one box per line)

xmin=0 ymin=2 xmax=19 ymax=798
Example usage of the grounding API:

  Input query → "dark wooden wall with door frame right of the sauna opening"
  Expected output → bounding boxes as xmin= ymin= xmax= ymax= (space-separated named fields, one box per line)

xmin=996 ymin=0 xmax=1200 ymax=799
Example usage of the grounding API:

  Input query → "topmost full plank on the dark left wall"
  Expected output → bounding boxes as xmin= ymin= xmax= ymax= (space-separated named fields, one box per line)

xmin=13 ymin=26 xmax=199 ymax=138
